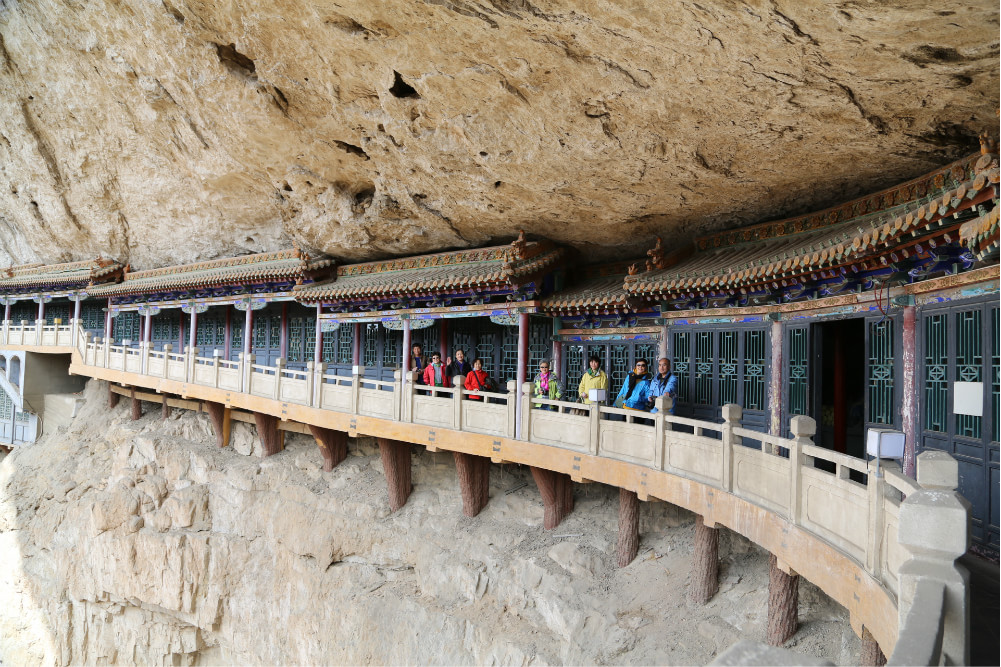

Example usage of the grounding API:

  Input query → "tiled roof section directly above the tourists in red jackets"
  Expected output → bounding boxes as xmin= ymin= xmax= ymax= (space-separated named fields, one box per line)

xmin=295 ymin=233 xmax=566 ymax=301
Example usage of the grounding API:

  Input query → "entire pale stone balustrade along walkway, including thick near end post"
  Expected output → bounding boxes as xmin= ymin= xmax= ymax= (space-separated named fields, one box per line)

xmin=2 ymin=322 xmax=968 ymax=664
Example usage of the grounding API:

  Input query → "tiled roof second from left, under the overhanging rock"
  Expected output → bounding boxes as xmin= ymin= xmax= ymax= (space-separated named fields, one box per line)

xmin=90 ymin=248 xmax=334 ymax=296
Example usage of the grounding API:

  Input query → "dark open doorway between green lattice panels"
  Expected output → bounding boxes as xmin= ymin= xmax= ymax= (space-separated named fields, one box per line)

xmin=813 ymin=317 xmax=866 ymax=459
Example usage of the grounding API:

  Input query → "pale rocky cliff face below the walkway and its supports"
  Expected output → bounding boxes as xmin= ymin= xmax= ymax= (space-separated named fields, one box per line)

xmin=0 ymin=382 xmax=860 ymax=665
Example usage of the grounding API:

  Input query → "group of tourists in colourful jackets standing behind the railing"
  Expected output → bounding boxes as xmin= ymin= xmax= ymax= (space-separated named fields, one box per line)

xmin=410 ymin=343 xmax=678 ymax=415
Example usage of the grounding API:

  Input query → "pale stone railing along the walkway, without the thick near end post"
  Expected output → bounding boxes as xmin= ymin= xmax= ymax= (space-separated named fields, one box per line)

xmin=4 ymin=322 xmax=964 ymax=656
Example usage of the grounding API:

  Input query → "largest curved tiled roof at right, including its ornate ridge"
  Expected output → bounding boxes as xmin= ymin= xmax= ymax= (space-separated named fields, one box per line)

xmin=625 ymin=146 xmax=998 ymax=298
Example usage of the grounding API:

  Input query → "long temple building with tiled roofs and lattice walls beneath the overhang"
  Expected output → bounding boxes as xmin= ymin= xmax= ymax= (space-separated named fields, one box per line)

xmin=0 ymin=140 xmax=1001 ymax=556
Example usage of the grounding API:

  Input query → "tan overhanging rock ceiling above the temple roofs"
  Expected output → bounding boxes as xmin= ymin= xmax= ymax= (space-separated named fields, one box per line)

xmin=0 ymin=0 xmax=998 ymax=269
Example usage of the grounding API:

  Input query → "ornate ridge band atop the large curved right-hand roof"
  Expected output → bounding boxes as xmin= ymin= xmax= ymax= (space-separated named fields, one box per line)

xmin=696 ymin=149 xmax=987 ymax=250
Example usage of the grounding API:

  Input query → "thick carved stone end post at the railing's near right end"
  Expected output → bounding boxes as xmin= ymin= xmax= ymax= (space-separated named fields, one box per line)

xmin=890 ymin=450 xmax=970 ymax=665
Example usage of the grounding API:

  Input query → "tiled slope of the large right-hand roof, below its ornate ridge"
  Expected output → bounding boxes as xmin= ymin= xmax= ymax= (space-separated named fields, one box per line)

xmin=625 ymin=155 xmax=998 ymax=295
